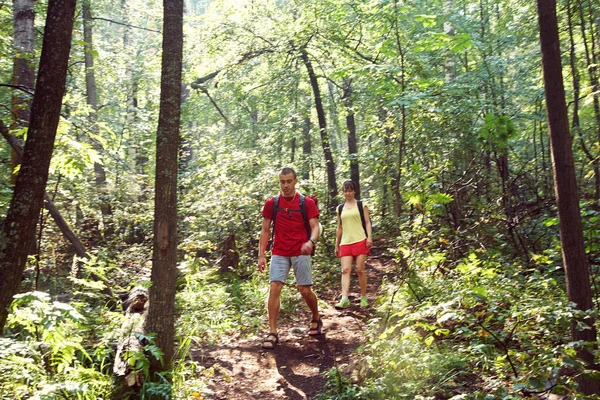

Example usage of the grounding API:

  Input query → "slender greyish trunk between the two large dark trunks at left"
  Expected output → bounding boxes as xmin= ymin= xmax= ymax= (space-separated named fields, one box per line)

xmin=82 ymin=0 xmax=113 ymax=237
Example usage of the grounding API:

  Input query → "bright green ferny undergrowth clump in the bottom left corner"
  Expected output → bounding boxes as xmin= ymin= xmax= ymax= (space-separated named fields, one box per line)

xmin=0 ymin=292 xmax=112 ymax=400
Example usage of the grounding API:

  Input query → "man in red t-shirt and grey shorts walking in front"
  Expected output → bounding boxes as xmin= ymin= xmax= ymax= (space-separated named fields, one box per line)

xmin=258 ymin=168 xmax=323 ymax=349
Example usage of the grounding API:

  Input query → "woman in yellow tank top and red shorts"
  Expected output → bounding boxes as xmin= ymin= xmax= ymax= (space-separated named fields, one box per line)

xmin=335 ymin=181 xmax=373 ymax=308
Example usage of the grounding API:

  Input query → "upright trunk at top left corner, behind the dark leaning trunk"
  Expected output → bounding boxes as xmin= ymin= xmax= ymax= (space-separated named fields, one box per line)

xmin=11 ymin=0 xmax=35 ymax=184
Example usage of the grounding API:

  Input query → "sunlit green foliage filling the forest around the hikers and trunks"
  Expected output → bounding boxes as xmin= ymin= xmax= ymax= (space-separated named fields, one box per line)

xmin=0 ymin=0 xmax=600 ymax=399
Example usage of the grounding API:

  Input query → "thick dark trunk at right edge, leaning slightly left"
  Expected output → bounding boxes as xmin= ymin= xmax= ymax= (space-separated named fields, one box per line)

xmin=537 ymin=0 xmax=600 ymax=394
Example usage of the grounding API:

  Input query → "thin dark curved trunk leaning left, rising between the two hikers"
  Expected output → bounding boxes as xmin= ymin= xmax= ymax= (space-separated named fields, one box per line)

xmin=300 ymin=47 xmax=338 ymax=212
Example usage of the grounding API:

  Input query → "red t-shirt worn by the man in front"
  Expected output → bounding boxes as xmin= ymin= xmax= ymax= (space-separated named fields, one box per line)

xmin=262 ymin=193 xmax=319 ymax=257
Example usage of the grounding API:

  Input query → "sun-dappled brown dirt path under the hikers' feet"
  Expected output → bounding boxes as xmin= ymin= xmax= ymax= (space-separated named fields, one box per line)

xmin=193 ymin=244 xmax=395 ymax=400
